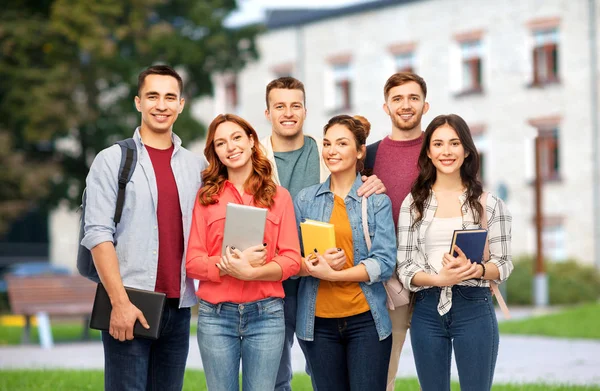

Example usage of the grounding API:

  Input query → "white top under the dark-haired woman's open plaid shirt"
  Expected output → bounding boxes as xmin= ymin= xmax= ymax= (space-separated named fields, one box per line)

xmin=425 ymin=216 xmax=462 ymax=274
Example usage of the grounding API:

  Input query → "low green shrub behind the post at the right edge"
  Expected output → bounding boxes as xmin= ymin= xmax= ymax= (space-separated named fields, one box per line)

xmin=506 ymin=256 xmax=600 ymax=305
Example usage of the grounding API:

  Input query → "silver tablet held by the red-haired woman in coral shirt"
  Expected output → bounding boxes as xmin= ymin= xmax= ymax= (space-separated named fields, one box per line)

xmin=221 ymin=203 xmax=267 ymax=255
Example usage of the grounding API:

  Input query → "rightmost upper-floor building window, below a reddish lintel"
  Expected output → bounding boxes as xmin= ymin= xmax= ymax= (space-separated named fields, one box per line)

xmin=533 ymin=28 xmax=558 ymax=86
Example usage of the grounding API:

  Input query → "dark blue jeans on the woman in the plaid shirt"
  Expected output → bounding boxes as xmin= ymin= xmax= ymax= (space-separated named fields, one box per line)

xmin=410 ymin=285 xmax=499 ymax=391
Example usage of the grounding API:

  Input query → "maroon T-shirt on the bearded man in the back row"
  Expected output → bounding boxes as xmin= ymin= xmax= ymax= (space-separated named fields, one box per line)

xmin=373 ymin=133 xmax=423 ymax=228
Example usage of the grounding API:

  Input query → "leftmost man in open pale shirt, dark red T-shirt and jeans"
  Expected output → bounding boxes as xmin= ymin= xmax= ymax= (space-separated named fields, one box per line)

xmin=81 ymin=66 xmax=206 ymax=391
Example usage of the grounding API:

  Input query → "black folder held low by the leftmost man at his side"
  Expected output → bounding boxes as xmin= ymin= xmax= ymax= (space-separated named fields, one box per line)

xmin=90 ymin=283 xmax=167 ymax=339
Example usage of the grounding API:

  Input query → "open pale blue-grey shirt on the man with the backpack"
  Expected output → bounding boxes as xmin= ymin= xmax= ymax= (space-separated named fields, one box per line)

xmin=81 ymin=128 xmax=206 ymax=307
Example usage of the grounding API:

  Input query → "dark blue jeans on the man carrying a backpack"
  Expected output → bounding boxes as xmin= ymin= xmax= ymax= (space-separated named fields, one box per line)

xmin=102 ymin=305 xmax=190 ymax=391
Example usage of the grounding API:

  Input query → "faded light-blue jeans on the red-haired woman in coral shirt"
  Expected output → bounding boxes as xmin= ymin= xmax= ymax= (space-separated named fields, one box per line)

xmin=198 ymin=298 xmax=285 ymax=391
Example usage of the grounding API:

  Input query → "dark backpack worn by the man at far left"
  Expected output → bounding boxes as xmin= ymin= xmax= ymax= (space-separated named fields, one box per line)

xmin=77 ymin=138 xmax=137 ymax=282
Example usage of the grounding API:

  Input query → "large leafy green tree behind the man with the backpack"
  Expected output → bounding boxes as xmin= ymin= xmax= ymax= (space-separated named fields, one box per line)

xmin=0 ymin=0 xmax=259 ymax=232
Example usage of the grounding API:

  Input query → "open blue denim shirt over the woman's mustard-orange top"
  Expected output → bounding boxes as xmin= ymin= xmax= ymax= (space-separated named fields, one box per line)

xmin=294 ymin=175 xmax=396 ymax=341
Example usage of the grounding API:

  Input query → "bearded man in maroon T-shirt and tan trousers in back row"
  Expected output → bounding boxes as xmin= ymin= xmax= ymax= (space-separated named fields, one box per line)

xmin=365 ymin=72 xmax=429 ymax=391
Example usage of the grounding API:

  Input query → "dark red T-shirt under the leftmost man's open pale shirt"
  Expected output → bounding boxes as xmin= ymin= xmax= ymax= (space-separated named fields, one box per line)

xmin=146 ymin=145 xmax=183 ymax=298
